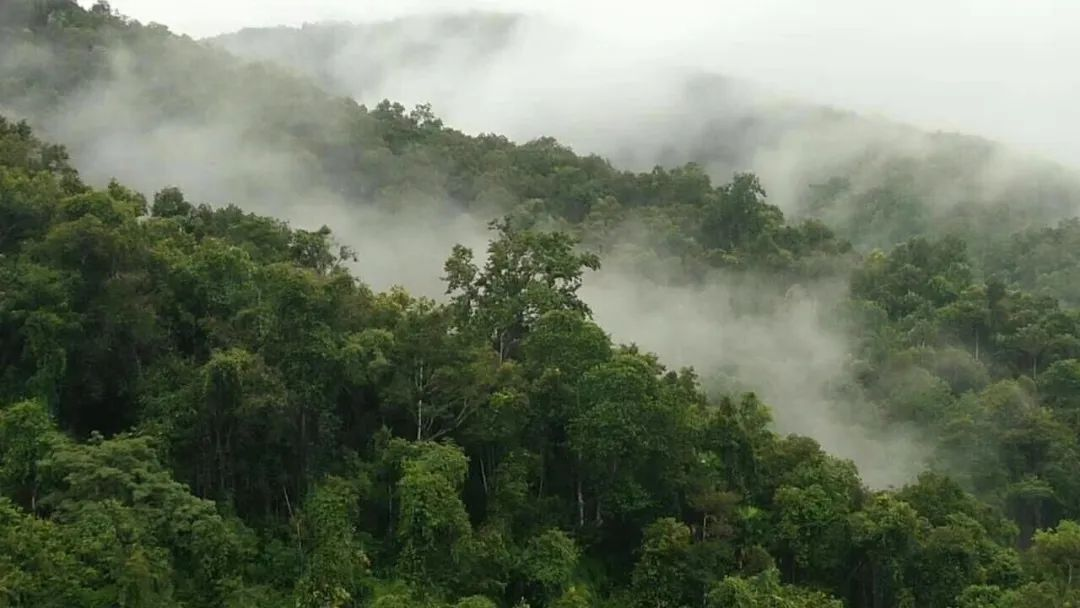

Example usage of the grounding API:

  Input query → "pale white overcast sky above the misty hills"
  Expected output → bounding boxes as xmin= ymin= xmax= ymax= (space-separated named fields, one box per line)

xmin=85 ymin=0 xmax=1080 ymax=166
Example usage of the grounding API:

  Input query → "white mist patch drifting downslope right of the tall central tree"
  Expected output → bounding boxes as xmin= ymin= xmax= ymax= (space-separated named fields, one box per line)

xmin=582 ymin=268 xmax=930 ymax=488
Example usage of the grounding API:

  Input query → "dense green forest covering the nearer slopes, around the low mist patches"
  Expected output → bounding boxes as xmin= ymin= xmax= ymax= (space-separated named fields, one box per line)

xmin=0 ymin=0 xmax=1080 ymax=608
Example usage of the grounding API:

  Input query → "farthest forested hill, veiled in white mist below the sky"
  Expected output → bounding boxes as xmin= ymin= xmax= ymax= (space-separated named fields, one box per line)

xmin=208 ymin=13 xmax=1080 ymax=253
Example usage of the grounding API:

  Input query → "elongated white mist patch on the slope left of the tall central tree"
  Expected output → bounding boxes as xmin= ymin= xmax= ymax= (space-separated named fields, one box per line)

xmin=0 ymin=41 xmax=489 ymax=298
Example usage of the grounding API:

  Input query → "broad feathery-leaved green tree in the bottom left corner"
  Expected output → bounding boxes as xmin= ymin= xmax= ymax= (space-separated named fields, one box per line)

xmin=0 ymin=412 xmax=241 ymax=607
